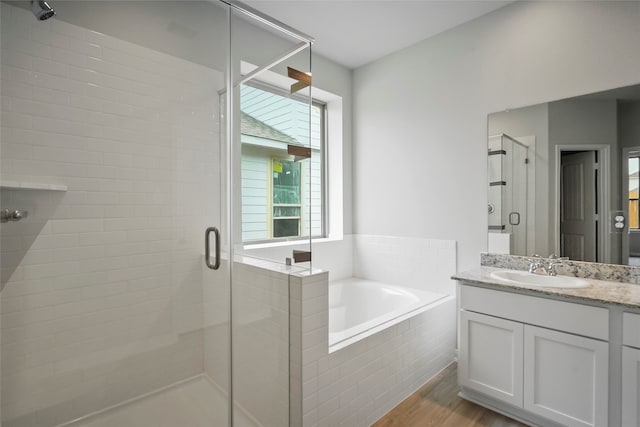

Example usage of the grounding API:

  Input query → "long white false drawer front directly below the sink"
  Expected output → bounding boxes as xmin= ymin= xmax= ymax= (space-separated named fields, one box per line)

xmin=460 ymin=282 xmax=608 ymax=341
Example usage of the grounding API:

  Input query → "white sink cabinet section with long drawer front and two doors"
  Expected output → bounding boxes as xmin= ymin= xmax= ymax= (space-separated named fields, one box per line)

xmin=458 ymin=283 xmax=609 ymax=426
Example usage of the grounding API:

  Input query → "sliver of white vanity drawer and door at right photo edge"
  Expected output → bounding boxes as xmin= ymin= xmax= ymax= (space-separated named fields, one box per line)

xmin=622 ymin=313 xmax=640 ymax=427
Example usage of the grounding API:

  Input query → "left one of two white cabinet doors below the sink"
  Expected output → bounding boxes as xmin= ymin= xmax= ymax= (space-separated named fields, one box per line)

xmin=458 ymin=310 xmax=523 ymax=407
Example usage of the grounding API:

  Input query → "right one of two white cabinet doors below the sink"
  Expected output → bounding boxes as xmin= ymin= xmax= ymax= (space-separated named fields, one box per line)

xmin=524 ymin=325 xmax=609 ymax=426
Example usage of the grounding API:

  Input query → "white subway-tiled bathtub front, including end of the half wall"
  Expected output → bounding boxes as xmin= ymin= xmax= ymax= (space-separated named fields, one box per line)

xmin=290 ymin=274 xmax=456 ymax=427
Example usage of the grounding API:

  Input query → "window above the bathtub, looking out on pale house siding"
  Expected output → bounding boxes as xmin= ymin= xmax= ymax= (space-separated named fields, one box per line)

xmin=240 ymin=83 xmax=326 ymax=243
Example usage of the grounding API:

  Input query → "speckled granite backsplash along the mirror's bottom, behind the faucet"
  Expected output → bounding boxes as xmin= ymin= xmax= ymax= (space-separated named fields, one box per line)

xmin=480 ymin=253 xmax=640 ymax=285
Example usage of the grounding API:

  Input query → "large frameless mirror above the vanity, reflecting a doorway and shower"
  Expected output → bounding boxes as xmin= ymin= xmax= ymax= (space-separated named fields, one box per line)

xmin=487 ymin=84 xmax=640 ymax=265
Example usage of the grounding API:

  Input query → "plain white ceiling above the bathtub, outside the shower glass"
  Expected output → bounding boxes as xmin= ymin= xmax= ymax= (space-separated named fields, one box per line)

xmin=244 ymin=0 xmax=512 ymax=68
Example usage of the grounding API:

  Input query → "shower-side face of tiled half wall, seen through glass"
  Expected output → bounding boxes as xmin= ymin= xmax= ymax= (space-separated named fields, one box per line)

xmin=203 ymin=259 xmax=295 ymax=426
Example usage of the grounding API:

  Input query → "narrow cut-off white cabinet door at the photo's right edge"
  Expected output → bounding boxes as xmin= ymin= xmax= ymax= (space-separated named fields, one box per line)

xmin=622 ymin=347 xmax=640 ymax=427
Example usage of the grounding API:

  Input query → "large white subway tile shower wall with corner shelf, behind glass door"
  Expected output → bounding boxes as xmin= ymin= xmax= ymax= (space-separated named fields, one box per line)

xmin=0 ymin=3 xmax=223 ymax=427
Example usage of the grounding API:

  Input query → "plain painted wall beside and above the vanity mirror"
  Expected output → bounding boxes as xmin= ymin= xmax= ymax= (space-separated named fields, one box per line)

xmin=353 ymin=2 xmax=640 ymax=270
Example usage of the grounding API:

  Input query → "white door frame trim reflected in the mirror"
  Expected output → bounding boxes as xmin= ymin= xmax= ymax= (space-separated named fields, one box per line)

xmin=553 ymin=144 xmax=611 ymax=263
